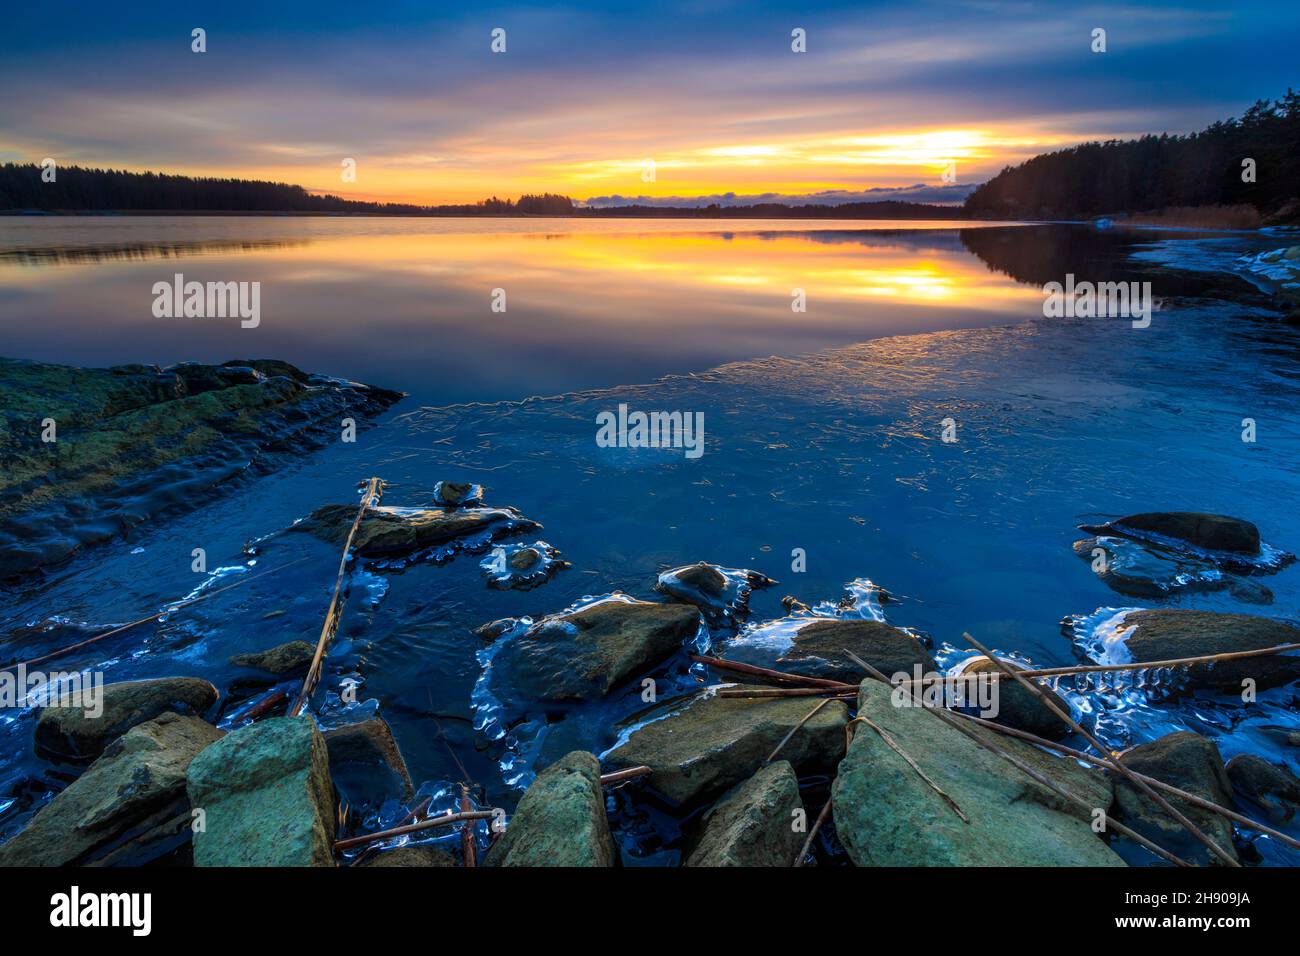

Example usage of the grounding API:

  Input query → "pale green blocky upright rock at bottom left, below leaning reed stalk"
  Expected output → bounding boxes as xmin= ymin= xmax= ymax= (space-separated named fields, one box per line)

xmin=187 ymin=717 xmax=334 ymax=866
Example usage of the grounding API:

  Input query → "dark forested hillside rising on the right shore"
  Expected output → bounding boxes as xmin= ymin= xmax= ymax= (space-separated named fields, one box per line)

xmin=965 ymin=90 xmax=1300 ymax=219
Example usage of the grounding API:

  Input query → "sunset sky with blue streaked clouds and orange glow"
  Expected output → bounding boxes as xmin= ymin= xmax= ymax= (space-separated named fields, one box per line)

xmin=0 ymin=0 xmax=1300 ymax=206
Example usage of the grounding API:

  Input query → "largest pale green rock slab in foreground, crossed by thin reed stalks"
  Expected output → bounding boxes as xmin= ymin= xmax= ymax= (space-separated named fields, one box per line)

xmin=831 ymin=680 xmax=1125 ymax=866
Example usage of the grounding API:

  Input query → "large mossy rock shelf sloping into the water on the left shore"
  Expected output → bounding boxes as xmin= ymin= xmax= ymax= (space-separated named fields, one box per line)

xmin=0 ymin=359 xmax=400 ymax=579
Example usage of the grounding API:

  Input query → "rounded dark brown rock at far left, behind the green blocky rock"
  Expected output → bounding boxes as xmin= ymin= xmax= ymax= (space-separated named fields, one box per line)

xmin=36 ymin=678 xmax=218 ymax=761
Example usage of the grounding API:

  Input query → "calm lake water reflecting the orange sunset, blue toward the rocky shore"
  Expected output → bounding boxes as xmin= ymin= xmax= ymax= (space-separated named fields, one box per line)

xmin=0 ymin=220 xmax=1300 ymax=862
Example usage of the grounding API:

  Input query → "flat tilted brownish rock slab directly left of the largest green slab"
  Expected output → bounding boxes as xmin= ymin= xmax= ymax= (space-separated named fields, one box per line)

xmin=605 ymin=695 xmax=849 ymax=808
